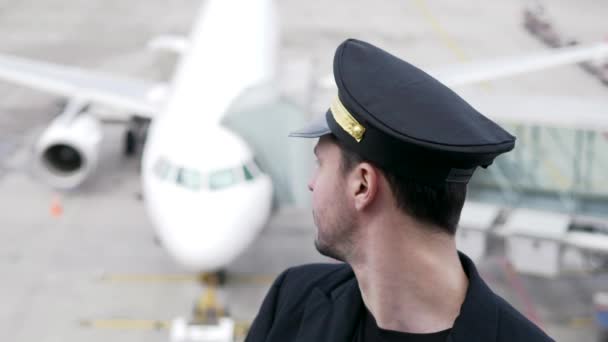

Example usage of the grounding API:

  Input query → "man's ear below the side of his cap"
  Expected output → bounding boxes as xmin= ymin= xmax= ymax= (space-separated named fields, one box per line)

xmin=348 ymin=163 xmax=380 ymax=211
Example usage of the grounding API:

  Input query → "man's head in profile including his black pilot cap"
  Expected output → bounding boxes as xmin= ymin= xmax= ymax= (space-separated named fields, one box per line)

xmin=290 ymin=39 xmax=515 ymax=259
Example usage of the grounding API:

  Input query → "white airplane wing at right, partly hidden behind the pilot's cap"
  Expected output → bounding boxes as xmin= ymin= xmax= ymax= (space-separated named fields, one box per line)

xmin=320 ymin=43 xmax=608 ymax=88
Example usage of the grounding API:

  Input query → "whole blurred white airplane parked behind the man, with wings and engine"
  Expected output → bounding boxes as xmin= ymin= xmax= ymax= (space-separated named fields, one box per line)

xmin=0 ymin=0 xmax=608 ymax=272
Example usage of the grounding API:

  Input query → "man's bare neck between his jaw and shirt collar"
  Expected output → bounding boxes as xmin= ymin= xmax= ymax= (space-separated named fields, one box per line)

xmin=348 ymin=214 xmax=468 ymax=333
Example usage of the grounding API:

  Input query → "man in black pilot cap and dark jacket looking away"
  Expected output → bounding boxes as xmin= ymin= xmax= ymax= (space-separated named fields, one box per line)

xmin=246 ymin=39 xmax=552 ymax=342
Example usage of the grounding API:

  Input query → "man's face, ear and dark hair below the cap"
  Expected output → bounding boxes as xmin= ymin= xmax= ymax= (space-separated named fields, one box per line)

xmin=308 ymin=134 xmax=466 ymax=260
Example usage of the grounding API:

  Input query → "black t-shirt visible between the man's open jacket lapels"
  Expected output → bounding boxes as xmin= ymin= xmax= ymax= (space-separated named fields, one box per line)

xmin=355 ymin=309 xmax=452 ymax=342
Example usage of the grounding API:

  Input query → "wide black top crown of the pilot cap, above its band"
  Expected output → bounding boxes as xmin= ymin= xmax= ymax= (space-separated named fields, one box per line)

xmin=334 ymin=39 xmax=515 ymax=154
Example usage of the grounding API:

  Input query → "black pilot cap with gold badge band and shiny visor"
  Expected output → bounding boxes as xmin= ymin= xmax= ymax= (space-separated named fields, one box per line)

xmin=289 ymin=39 xmax=515 ymax=184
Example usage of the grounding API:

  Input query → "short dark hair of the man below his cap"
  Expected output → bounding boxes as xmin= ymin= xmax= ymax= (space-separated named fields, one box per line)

xmin=333 ymin=138 xmax=467 ymax=235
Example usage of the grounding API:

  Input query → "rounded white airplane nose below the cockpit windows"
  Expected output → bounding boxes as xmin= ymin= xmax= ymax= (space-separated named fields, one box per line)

xmin=147 ymin=176 xmax=272 ymax=272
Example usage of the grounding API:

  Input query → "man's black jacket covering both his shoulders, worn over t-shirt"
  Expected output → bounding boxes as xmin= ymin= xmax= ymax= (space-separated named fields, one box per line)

xmin=245 ymin=254 xmax=553 ymax=342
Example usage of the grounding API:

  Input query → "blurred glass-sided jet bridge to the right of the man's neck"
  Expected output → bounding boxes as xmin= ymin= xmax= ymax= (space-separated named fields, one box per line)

xmin=456 ymin=115 xmax=608 ymax=277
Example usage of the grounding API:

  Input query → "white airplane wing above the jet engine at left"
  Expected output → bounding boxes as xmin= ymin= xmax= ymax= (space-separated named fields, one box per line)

xmin=0 ymin=55 xmax=167 ymax=117
